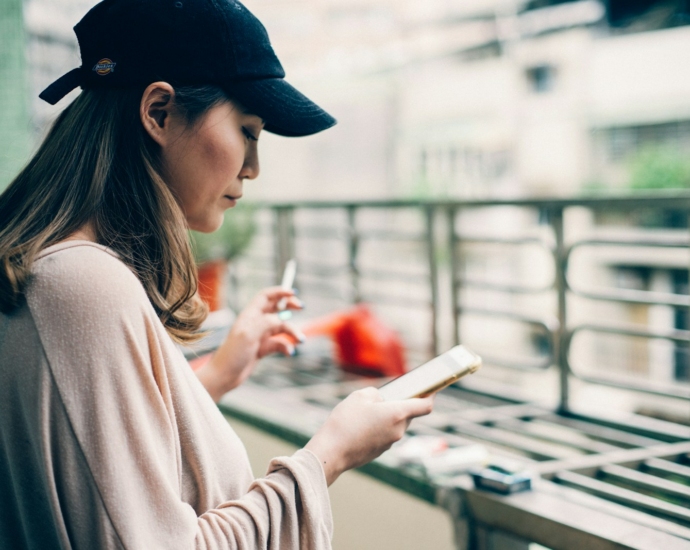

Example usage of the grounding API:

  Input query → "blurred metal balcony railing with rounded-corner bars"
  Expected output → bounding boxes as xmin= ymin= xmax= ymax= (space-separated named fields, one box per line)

xmin=232 ymin=194 xmax=690 ymax=411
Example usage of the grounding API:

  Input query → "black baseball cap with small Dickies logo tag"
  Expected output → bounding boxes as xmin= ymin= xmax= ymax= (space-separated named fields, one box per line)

xmin=39 ymin=0 xmax=336 ymax=136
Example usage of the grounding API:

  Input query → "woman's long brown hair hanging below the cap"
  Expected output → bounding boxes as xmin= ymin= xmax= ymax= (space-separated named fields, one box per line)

xmin=0 ymin=86 xmax=228 ymax=342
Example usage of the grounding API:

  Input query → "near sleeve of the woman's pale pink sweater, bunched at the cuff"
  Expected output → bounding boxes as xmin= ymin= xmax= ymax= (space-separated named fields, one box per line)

xmin=27 ymin=247 xmax=332 ymax=550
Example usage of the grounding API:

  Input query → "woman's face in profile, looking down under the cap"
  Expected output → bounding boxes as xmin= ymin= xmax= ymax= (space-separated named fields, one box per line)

xmin=161 ymin=101 xmax=264 ymax=233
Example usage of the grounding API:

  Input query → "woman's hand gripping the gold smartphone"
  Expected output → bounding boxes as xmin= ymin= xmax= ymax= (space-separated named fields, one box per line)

xmin=305 ymin=388 xmax=434 ymax=485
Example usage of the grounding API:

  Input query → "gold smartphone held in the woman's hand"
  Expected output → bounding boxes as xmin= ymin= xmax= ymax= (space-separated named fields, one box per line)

xmin=379 ymin=346 xmax=482 ymax=401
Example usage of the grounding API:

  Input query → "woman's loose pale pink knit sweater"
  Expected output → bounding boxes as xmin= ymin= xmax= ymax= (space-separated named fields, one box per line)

xmin=0 ymin=241 xmax=332 ymax=550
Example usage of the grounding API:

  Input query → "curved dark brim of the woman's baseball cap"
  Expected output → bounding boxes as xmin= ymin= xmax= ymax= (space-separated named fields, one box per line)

xmin=225 ymin=78 xmax=337 ymax=137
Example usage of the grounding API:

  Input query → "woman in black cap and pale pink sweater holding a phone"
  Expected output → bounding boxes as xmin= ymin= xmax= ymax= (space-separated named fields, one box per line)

xmin=0 ymin=0 xmax=432 ymax=550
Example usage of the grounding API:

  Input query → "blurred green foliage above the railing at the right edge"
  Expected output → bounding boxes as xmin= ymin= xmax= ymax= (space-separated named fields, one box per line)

xmin=630 ymin=147 xmax=690 ymax=190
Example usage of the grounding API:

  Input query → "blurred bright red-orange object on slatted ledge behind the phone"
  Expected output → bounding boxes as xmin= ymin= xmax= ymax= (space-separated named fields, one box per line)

xmin=302 ymin=304 xmax=406 ymax=376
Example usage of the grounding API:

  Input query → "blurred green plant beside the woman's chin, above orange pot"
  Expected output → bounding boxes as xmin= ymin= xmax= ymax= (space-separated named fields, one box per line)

xmin=189 ymin=203 xmax=256 ymax=264
